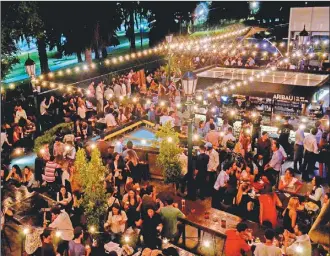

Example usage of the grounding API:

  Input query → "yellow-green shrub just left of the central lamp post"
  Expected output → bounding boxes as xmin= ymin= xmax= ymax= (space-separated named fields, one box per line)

xmin=156 ymin=122 xmax=182 ymax=183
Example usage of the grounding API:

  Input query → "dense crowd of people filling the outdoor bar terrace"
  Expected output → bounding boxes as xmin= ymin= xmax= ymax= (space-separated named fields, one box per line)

xmin=1 ymin=57 xmax=330 ymax=256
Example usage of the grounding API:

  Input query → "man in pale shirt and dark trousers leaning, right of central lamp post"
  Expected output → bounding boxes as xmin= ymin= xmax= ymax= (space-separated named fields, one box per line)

xmin=212 ymin=163 xmax=233 ymax=209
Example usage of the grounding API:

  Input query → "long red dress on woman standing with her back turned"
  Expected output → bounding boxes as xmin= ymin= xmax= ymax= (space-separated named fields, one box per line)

xmin=259 ymin=193 xmax=278 ymax=228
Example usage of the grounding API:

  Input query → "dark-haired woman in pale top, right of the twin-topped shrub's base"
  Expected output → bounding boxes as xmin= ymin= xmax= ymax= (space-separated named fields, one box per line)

xmin=104 ymin=203 xmax=127 ymax=242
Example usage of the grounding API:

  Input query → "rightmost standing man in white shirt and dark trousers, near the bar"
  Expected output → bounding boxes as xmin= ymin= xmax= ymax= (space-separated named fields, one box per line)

xmin=301 ymin=128 xmax=319 ymax=181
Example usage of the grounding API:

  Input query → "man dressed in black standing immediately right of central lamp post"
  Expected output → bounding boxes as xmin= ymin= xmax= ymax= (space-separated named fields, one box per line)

xmin=196 ymin=145 xmax=210 ymax=200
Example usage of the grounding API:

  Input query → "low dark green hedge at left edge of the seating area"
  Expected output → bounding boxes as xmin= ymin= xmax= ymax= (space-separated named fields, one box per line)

xmin=33 ymin=123 xmax=73 ymax=153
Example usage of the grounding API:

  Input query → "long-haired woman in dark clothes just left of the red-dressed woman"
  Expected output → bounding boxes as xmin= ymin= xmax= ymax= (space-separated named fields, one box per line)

xmin=236 ymin=183 xmax=253 ymax=219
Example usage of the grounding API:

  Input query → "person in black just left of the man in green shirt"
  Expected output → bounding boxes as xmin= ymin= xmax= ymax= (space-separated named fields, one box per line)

xmin=141 ymin=207 xmax=163 ymax=249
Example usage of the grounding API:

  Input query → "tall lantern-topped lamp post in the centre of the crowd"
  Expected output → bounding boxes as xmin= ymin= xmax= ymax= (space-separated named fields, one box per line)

xmin=181 ymin=71 xmax=197 ymax=178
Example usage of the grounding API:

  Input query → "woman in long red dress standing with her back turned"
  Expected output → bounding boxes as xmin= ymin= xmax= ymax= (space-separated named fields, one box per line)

xmin=259 ymin=184 xmax=282 ymax=228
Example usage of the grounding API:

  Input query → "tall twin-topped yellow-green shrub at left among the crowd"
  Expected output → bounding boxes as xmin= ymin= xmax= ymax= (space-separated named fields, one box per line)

xmin=75 ymin=148 xmax=107 ymax=227
